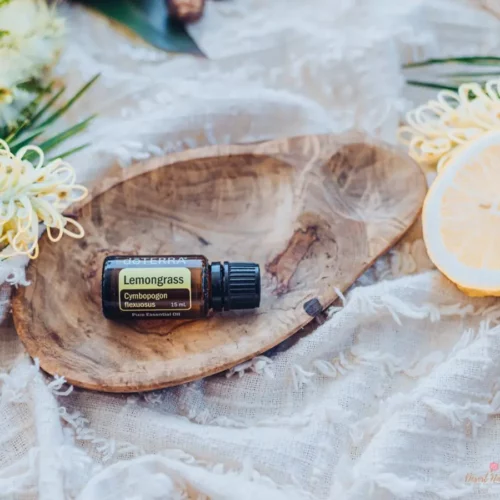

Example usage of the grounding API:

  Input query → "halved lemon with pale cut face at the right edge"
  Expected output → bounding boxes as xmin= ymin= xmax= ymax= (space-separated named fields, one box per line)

xmin=422 ymin=131 xmax=500 ymax=296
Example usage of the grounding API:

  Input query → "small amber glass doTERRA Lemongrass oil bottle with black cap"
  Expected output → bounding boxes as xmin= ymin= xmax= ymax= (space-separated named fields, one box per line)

xmin=102 ymin=255 xmax=260 ymax=319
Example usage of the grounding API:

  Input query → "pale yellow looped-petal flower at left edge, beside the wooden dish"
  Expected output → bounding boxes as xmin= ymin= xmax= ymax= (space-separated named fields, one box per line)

xmin=0 ymin=139 xmax=87 ymax=259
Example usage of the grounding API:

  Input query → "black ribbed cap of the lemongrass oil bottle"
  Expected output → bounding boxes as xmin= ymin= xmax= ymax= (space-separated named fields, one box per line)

xmin=210 ymin=262 xmax=260 ymax=311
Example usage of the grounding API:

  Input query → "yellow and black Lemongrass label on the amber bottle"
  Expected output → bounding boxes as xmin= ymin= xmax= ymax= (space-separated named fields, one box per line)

xmin=118 ymin=267 xmax=191 ymax=311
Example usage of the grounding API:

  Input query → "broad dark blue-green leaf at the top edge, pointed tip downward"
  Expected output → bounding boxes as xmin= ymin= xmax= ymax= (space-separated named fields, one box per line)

xmin=80 ymin=0 xmax=203 ymax=55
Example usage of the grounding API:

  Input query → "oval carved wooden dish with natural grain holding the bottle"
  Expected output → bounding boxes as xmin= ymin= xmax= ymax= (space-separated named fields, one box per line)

xmin=13 ymin=136 xmax=426 ymax=392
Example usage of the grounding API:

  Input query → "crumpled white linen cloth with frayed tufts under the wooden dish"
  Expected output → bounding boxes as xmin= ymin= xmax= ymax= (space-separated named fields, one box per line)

xmin=0 ymin=0 xmax=500 ymax=500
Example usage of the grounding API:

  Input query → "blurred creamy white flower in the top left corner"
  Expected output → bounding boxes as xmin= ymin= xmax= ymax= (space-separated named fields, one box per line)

xmin=0 ymin=0 xmax=65 ymax=127
